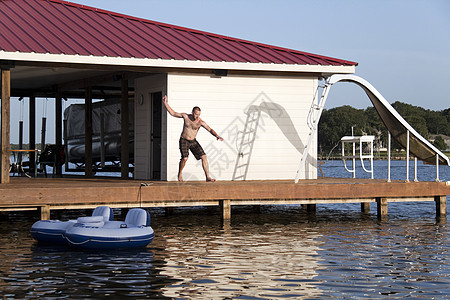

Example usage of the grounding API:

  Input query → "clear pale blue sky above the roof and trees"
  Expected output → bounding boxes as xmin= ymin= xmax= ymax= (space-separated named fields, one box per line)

xmin=7 ymin=0 xmax=450 ymax=142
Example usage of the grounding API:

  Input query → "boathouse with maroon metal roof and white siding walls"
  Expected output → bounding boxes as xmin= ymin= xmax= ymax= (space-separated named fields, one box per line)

xmin=0 ymin=0 xmax=357 ymax=182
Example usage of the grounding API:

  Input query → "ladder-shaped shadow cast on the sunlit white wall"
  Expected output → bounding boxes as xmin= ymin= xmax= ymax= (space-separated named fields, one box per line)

xmin=233 ymin=106 xmax=261 ymax=180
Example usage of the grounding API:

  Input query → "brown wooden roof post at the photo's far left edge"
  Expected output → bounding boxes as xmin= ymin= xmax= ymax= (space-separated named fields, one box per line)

xmin=0 ymin=67 xmax=11 ymax=183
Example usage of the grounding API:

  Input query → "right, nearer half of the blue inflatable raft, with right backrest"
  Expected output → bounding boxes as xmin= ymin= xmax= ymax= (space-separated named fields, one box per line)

xmin=65 ymin=208 xmax=154 ymax=249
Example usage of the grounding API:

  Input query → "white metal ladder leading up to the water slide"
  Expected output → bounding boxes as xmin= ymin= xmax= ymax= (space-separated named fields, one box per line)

xmin=295 ymin=81 xmax=332 ymax=183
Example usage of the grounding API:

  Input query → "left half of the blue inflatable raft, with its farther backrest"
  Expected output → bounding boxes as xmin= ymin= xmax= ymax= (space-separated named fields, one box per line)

xmin=30 ymin=206 xmax=114 ymax=244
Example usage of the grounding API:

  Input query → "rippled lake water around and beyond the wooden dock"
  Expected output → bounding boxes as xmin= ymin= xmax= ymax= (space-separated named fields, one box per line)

xmin=0 ymin=161 xmax=450 ymax=299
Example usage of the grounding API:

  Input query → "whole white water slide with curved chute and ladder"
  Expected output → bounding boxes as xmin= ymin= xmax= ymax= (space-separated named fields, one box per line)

xmin=295 ymin=74 xmax=450 ymax=182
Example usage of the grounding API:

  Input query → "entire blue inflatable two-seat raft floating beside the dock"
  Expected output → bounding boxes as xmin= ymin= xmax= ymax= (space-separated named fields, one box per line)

xmin=31 ymin=206 xmax=154 ymax=249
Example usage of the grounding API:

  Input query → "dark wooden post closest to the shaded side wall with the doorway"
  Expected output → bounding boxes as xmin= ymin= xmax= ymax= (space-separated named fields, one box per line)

xmin=120 ymin=75 xmax=130 ymax=179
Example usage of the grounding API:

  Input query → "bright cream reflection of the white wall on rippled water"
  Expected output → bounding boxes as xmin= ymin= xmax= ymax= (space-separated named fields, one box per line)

xmin=161 ymin=216 xmax=319 ymax=299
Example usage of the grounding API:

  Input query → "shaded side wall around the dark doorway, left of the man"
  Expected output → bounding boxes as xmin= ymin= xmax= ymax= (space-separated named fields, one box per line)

xmin=134 ymin=74 xmax=167 ymax=180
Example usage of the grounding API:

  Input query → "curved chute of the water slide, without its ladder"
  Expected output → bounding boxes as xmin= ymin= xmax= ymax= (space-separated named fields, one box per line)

xmin=328 ymin=74 xmax=450 ymax=166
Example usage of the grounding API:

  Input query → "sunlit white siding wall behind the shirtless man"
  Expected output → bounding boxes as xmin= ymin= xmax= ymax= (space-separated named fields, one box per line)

xmin=164 ymin=73 xmax=317 ymax=181
